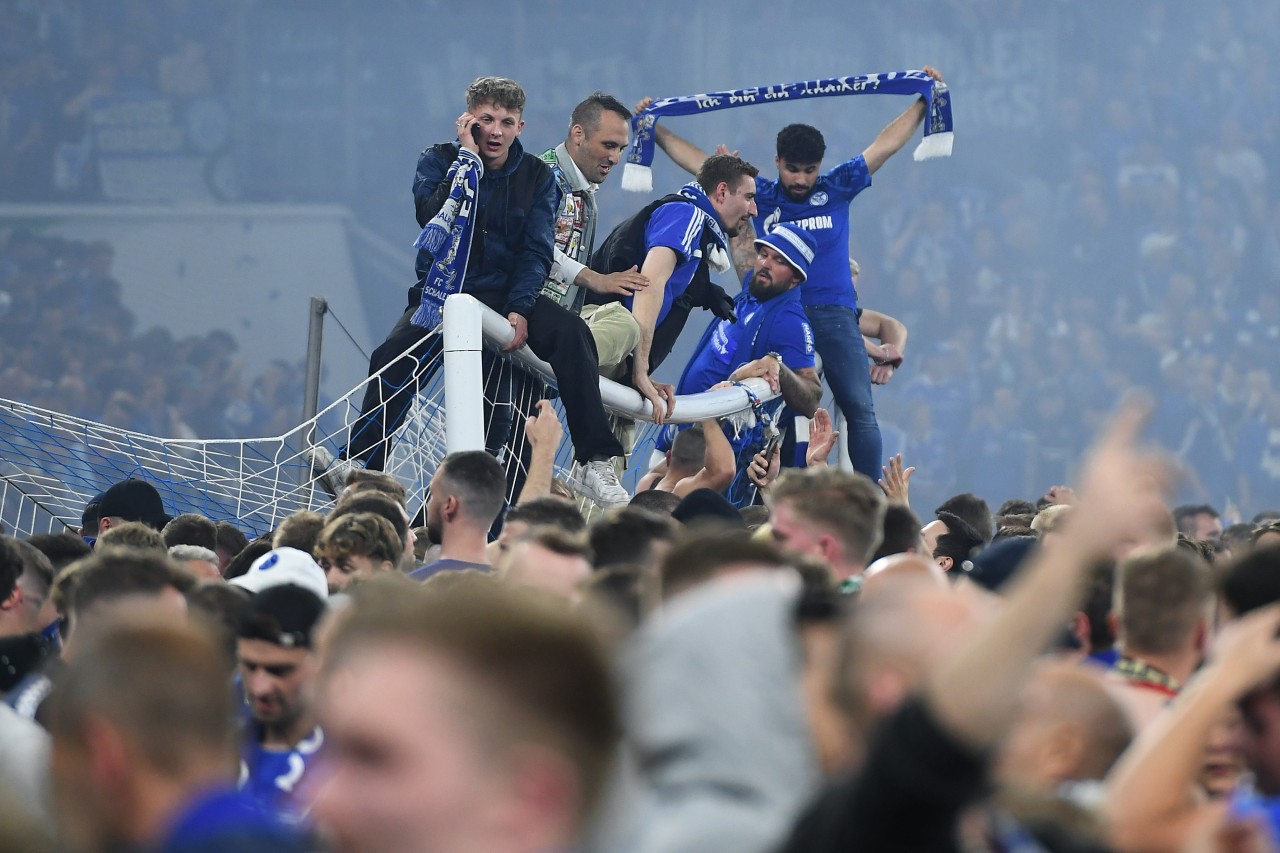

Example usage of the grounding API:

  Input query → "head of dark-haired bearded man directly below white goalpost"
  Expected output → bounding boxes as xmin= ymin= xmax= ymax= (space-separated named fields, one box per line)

xmin=410 ymin=451 xmax=507 ymax=580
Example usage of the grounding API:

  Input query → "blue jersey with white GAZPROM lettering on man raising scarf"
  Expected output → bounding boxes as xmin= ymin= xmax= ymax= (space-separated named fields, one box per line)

xmin=755 ymin=154 xmax=872 ymax=309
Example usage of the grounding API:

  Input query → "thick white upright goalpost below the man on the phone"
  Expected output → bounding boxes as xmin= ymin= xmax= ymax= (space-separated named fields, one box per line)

xmin=444 ymin=293 xmax=485 ymax=453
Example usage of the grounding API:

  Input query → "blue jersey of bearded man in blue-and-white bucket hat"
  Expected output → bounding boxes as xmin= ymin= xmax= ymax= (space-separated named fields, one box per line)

xmin=676 ymin=283 xmax=814 ymax=394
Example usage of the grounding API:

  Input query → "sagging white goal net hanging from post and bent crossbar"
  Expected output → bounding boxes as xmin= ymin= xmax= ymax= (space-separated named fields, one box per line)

xmin=0 ymin=295 xmax=778 ymax=527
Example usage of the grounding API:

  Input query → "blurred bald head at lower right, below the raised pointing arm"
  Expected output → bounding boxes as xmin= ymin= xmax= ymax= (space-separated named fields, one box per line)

xmin=996 ymin=661 xmax=1133 ymax=793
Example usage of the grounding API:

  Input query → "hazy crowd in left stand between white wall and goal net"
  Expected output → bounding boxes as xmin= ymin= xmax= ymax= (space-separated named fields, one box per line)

xmin=0 ymin=231 xmax=302 ymax=438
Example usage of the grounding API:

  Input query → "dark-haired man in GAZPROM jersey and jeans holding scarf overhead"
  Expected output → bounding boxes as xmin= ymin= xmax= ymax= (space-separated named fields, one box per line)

xmin=636 ymin=65 xmax=950 ymax=480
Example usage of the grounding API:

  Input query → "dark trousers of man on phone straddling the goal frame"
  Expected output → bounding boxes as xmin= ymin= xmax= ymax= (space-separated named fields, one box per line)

xmin=339 ymin=287 xmax=623 ymax=471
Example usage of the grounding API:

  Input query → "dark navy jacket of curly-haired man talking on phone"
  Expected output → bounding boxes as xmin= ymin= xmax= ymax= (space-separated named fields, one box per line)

xmin=413 ymin=140 xmax=556 ymax=319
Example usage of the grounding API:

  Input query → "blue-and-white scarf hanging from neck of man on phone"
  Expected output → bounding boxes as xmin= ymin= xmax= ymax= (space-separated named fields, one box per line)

xmin=410 ymin=147 xmax=484 ymax=329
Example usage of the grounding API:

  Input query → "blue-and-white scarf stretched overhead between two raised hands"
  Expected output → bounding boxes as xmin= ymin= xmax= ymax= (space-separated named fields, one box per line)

xmin=622 ymin=70 xmax=951 ymax=192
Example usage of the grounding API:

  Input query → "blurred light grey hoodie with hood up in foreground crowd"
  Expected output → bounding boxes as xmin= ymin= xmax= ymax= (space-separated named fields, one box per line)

xmin=598 ymin=571 xmax=820 ymax=853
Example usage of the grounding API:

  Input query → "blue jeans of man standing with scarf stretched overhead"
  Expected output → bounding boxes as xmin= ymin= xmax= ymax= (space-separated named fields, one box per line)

xmin=804 ymin=305 xmax=884 ymax=483
